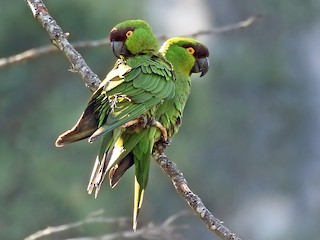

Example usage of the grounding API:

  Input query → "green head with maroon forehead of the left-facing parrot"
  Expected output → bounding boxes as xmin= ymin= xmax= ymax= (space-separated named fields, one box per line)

xmin=109 ymin=20 xmax=159 ymax=58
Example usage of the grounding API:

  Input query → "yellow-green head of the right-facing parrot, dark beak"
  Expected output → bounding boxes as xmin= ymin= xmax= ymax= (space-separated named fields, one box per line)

xmin=160 ymin=37 xmax=209 ymax=77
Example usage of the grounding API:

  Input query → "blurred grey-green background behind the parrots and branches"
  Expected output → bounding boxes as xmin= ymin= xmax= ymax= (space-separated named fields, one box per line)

xmin=0 ymin=0 xmax=320 ymax=240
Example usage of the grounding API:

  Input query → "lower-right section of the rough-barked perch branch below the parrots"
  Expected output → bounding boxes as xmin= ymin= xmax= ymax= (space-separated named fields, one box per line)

xmin=153 ymin=142 xmax=241 ymax=240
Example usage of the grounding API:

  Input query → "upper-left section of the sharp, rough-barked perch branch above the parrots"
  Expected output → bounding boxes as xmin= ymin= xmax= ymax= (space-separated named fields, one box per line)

xmin=26 ymin=0 xmax=101 ymax=91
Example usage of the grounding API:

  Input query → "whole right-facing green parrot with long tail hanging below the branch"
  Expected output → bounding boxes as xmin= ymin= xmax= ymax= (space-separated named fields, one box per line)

xmin=109 ymin=38 xmax=209 ymax=229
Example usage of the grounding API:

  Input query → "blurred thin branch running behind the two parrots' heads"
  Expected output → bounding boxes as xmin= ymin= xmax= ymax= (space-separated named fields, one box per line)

xmin=0 ymin=15 xmax=261 ymax=68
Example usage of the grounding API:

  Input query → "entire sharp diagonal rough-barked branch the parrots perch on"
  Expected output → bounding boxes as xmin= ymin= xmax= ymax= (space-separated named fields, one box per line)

xmin=26 ymin=0 xmax=245 ymax=240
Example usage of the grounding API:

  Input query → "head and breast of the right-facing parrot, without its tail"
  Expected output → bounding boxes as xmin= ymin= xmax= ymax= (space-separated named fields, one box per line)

xmin=154 ymin=37 xmax=209 ymax=138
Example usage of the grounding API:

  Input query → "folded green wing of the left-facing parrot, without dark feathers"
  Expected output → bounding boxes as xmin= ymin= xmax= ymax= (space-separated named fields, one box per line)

xmin=89 ymin=55 xmax=175 ymax=141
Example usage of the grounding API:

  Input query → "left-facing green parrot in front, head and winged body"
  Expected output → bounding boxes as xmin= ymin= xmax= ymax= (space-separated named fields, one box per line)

xmin=56 ymin=20 xmax=169 ymax=147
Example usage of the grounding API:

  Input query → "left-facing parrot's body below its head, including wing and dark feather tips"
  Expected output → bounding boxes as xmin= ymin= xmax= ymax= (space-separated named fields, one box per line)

xmin=56 ymin=55 xmax=175 ymax=147
